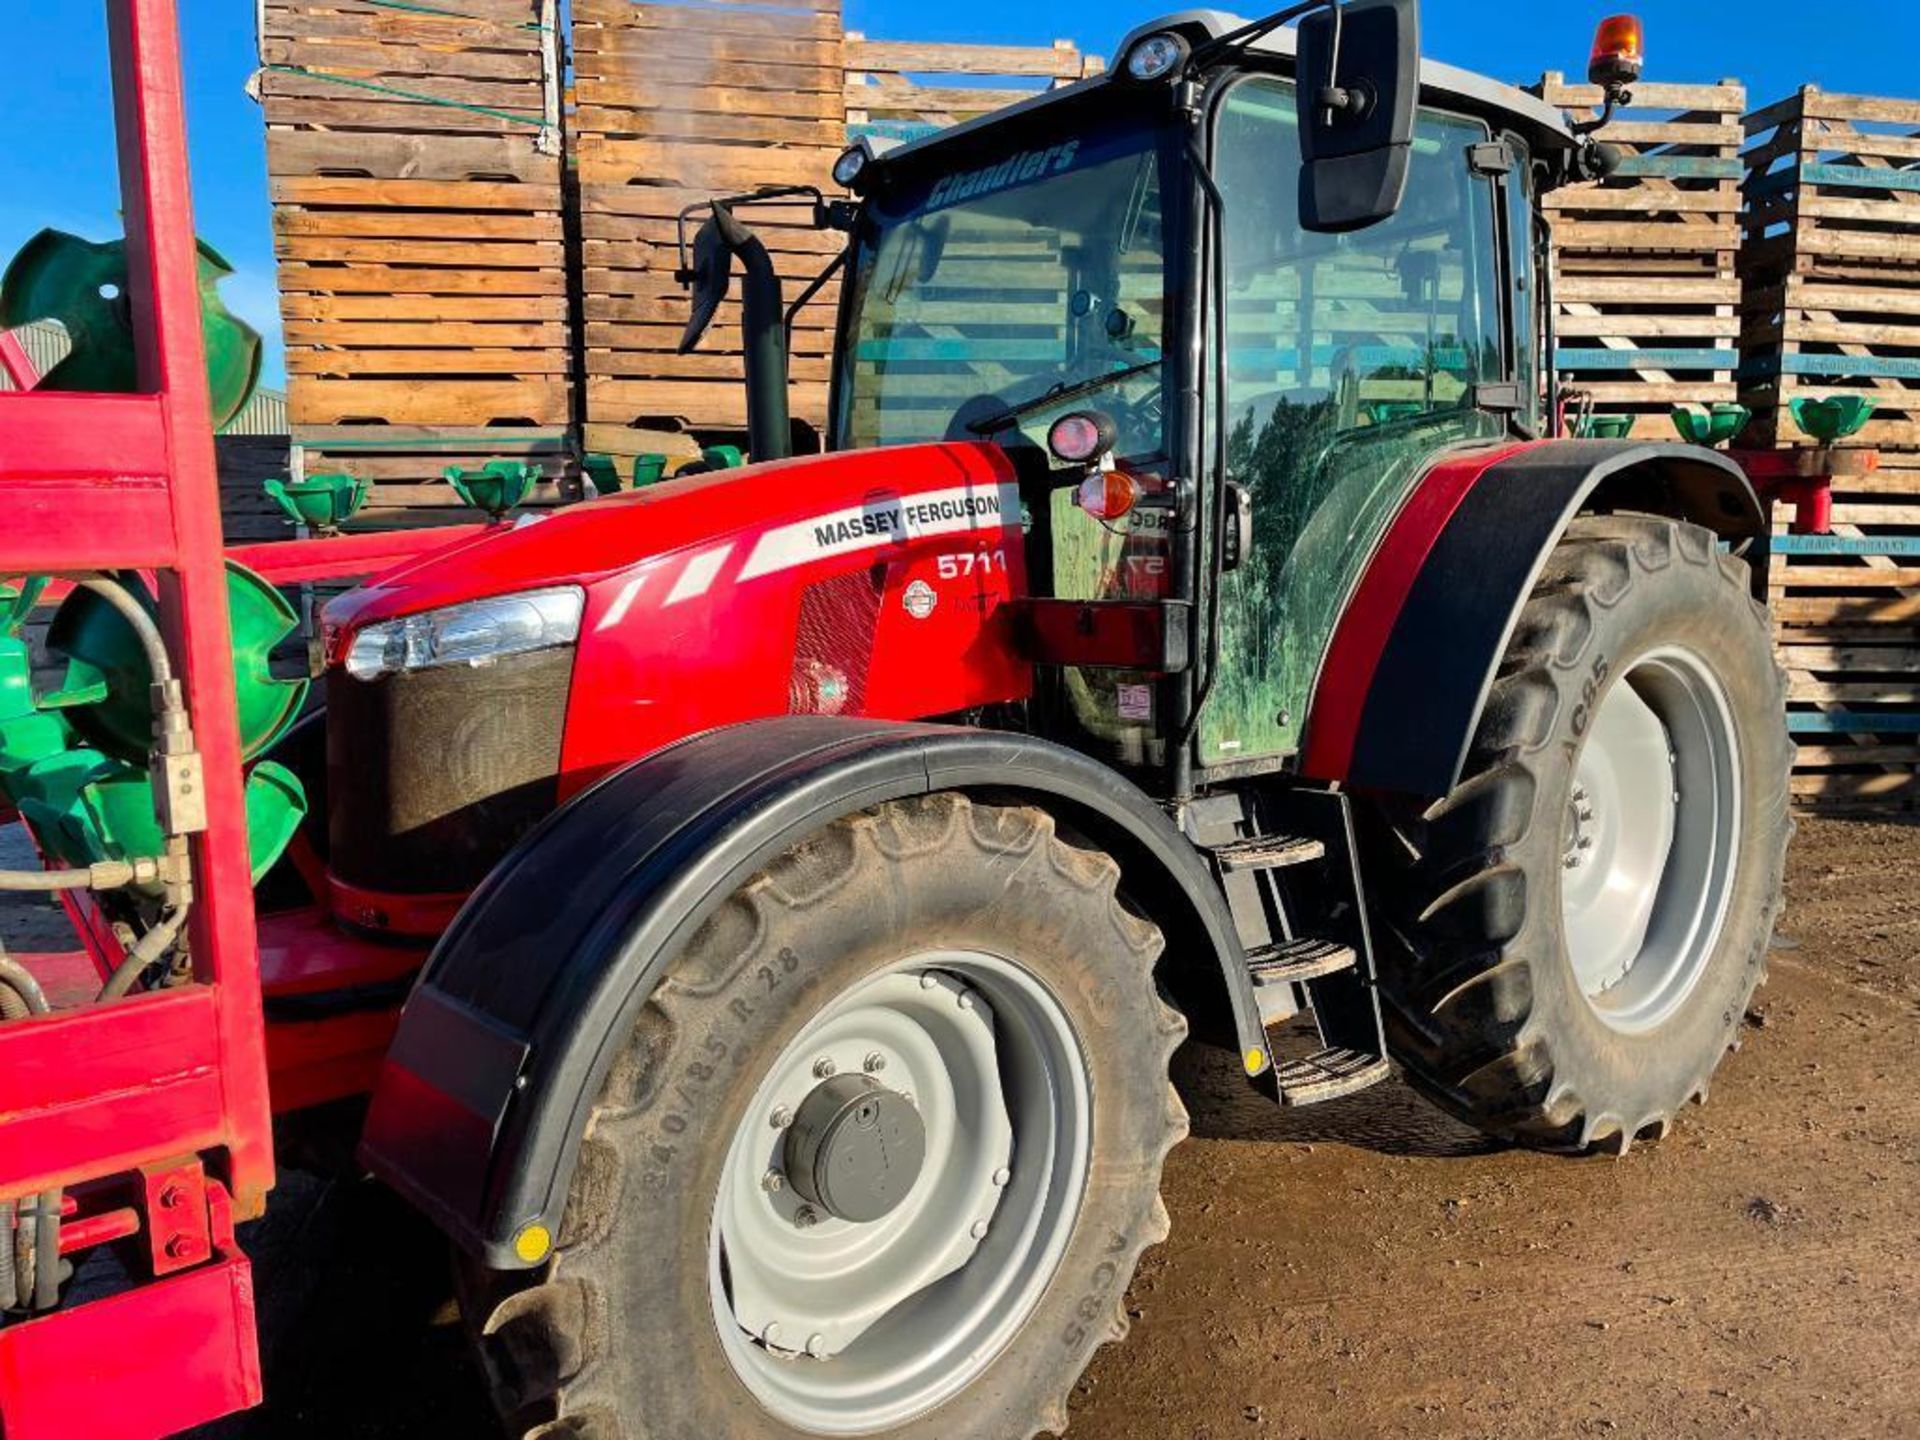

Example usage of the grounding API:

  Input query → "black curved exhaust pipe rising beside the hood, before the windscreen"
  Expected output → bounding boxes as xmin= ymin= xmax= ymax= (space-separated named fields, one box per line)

xmin=680 ymin=202 xmax=793 ymax=461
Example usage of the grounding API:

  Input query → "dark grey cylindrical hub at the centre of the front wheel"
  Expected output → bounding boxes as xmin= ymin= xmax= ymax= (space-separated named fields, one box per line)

xmin=783 ymin=1075 xmax=927 ymax=1223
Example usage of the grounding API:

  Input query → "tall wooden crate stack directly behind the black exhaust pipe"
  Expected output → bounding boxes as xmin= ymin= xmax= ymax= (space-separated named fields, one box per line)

xmin=570 ymin=0 xmax=847 ymax=468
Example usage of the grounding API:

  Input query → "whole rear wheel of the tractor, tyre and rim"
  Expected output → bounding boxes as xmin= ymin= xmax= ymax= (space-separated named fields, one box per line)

xmin=1371 ymin=516 xmax=1791 ymax=1152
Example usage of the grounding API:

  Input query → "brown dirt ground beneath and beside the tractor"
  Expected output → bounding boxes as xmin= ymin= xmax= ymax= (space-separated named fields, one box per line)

xmin=0 ymin=820 xmax=1920 ymax=1440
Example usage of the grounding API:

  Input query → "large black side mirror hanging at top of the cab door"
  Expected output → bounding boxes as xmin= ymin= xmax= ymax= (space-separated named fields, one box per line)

xmin=1296 ymin=0 xmax=1421 ymax=234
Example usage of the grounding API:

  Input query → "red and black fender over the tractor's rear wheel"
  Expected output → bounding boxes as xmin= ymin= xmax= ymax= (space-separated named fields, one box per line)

xmin=1302 ymin=440 xmax=1768 ymax=797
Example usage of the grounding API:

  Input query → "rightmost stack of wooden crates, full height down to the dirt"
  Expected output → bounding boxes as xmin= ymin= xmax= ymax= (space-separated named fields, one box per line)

xmin=1741 ymin=86 xmax=1920 ymax=810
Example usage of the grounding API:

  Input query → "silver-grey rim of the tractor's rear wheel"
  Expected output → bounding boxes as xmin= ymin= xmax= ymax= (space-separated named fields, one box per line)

xmin=1561 ymin=645 xmax=1743 ymax=1035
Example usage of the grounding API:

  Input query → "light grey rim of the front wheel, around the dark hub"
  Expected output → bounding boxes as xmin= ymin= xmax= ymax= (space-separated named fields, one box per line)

xmin=708 ymin=950 xmax=1092 ymax=1434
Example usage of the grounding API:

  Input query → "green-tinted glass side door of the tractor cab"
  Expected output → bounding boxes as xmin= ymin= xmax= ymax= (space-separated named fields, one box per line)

xmin=1200 ymin=77 xmax=1515 ymax=768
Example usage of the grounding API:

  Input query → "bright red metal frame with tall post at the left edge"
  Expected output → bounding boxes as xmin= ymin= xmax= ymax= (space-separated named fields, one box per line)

xmin=0 ymin=0 xmax=273 ymax=1440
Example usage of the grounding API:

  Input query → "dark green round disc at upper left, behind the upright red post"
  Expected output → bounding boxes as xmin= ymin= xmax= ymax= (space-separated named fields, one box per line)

xmin=0 ymin=230 xmax=261 ymax=430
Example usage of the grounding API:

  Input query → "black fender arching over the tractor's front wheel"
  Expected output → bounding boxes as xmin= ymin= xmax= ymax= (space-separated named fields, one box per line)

xmin=361 ymin=716 xmax=1265 ymax=1269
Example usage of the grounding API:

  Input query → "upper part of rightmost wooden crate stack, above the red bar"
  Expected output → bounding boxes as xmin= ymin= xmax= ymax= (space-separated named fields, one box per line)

xmin=1740 ymin=86 xmax=1920 ymax=449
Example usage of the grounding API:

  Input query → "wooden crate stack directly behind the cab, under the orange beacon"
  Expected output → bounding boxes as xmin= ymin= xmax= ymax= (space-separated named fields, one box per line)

xmin=1540 ymin=73 xmax=1747 ymax=440
